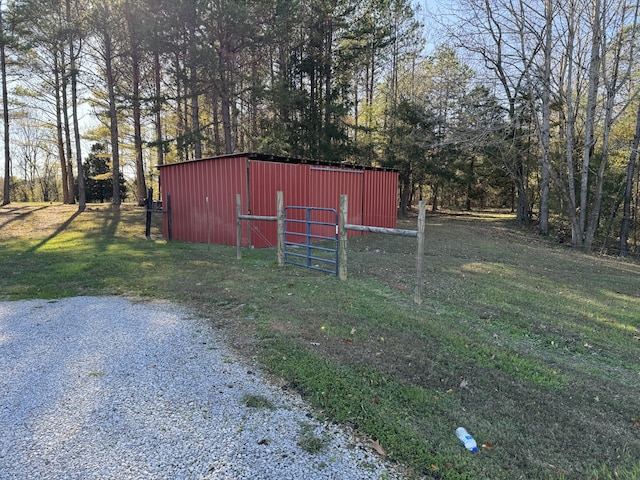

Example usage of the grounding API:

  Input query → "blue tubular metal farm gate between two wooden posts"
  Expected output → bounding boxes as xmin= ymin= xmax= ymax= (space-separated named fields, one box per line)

xmin=284 ymin=207 xmax=338 ymax=275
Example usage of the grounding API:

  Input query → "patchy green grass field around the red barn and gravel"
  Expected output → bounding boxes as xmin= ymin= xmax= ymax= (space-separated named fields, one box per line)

xmin=0 ymin=204 xmax=640 ymax=480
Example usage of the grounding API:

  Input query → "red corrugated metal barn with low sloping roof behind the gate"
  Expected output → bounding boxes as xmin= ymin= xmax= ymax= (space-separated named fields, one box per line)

xmin=160 ymin=153 xmax=398 ymax=247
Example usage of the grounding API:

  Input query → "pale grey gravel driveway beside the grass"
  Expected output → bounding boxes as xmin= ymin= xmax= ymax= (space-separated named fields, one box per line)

xmin=0 ymin=297 xmax=400 ymax=480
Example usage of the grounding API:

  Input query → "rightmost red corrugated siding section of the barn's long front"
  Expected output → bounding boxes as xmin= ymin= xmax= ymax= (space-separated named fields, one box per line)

xmin=362 ymin=170 xmax=398 ymax=228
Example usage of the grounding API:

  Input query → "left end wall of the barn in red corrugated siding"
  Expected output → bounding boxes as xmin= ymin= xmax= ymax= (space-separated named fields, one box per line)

xmin=161 ymin=157 xmax=247 ymax=245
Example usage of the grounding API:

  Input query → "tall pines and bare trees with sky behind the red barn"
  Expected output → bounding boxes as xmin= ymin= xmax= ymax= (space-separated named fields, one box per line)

xmin=0 ymin=0 xmax=640 ymax=255
